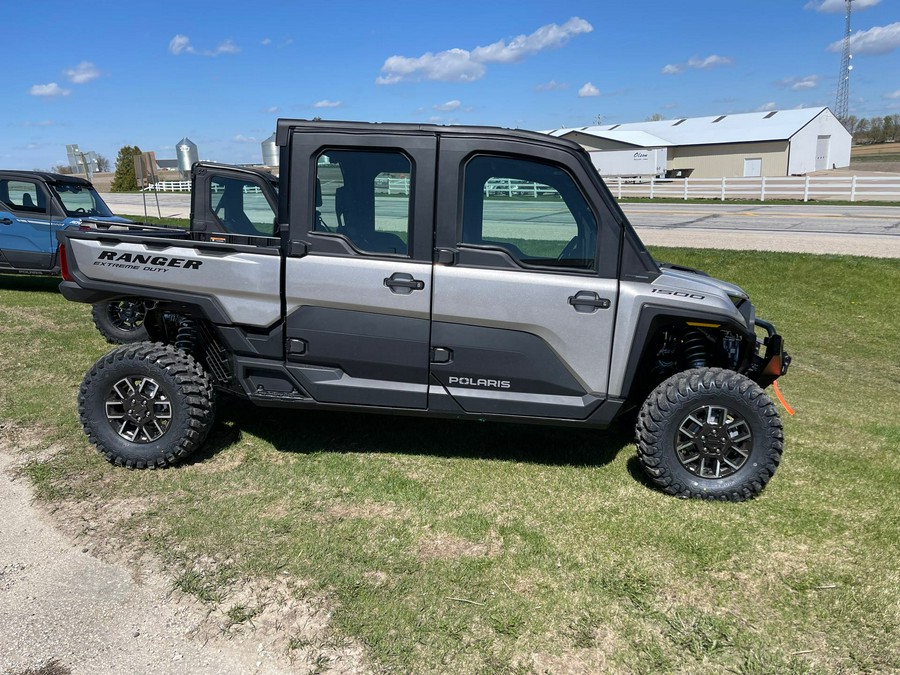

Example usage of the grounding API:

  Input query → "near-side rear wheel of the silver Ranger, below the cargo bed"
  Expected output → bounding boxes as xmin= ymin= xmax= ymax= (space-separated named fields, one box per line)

xmin=78 ymin=342 xmax=214 ymax=469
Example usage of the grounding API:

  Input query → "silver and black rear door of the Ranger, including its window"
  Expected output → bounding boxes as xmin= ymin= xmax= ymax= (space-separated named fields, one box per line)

xmin=281 ymin=129 xmax=436 ymax=408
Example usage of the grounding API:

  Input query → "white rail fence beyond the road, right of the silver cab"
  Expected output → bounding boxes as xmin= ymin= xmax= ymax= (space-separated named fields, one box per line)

xmin=603 ymin=176 xmax=900 ymax=202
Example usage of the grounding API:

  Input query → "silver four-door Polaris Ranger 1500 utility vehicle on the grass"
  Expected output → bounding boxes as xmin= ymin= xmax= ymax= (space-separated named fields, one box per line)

xmin=58 ymin=120 xmax=790 ymax=500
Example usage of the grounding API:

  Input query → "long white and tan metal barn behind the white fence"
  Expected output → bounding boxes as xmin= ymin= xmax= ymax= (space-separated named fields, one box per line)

xmin=550 ymin=108 xmax=852 ymax=178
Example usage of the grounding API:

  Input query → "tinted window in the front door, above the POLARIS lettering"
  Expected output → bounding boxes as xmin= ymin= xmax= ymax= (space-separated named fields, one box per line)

xmin=461 ymin=156 xmax=597 ymax=270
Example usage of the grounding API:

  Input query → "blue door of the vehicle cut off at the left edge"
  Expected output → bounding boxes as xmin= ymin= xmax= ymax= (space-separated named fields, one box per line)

xmin=0 ymin=178 xmax=56 ymax=270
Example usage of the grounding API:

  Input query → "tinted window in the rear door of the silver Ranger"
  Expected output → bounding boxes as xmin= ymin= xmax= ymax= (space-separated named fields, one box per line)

xmin=314 ymin=149 xmax=412 ymax=255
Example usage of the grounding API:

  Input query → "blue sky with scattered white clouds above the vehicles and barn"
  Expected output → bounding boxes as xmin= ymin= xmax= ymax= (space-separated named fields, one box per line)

xmin=7 ymin=0 xmax=900 ymax=169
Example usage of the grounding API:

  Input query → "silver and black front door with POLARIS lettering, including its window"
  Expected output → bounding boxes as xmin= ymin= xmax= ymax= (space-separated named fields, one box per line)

xmin=431 ymin=137 xmax=619 ymax=419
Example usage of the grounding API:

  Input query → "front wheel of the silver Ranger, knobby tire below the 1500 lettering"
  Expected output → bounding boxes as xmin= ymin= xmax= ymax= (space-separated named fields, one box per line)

xmin=636 ymin=368 xmax=784 ymax=501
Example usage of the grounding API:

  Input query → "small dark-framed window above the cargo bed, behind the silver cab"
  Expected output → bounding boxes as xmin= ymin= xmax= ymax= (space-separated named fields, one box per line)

xmin=209 ymin=176 xmax=275 ymax=237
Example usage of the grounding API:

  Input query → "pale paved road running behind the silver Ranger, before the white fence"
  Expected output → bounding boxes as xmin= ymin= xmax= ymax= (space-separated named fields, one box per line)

xmin=103 ymin=194 xmax=900 ymax=258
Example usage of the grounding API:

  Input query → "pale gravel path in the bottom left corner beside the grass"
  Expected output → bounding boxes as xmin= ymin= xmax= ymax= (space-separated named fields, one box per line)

xmin=0 ymin=433 xmax=370 ymax=675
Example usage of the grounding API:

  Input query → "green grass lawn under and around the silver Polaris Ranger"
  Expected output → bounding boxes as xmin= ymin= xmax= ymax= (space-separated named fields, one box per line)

xmin=0 ymin=249 xmax=900 ymax=673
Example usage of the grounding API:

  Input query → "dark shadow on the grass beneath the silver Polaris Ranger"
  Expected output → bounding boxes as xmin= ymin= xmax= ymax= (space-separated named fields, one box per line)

xmin=189 ymin=397 xmax=634 ymax=466
